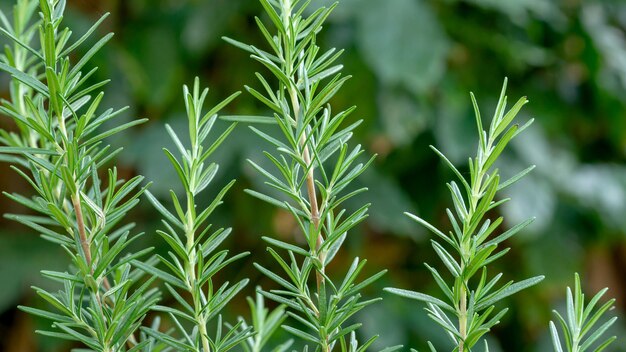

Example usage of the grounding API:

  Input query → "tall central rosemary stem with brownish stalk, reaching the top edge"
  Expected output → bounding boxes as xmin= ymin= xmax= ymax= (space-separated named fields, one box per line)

xmin=226 ymin=0 xmax=385 ymax=352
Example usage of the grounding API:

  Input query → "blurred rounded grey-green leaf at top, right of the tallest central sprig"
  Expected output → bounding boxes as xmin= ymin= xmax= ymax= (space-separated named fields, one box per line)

xmin=355 ymin=0 xmax=449 ymax=92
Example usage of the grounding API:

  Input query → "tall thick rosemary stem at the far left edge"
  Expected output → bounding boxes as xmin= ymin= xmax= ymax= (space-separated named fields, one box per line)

xmin=0 ymin=0 xmax=158 ymax=352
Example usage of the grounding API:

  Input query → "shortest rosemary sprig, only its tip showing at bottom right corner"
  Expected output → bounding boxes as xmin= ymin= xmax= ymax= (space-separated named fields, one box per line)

xmin=550 ymin=274 xmax=617 ymax=352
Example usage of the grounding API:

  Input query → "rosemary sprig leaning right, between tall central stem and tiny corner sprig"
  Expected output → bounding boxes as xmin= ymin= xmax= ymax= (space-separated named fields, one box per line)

xmin=385 ymin=80 xmax=543 ymax=352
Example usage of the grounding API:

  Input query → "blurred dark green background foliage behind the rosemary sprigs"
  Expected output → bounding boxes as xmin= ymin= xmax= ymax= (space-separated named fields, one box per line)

xmin=0 ymin=0 xmax=626 ymax=352
